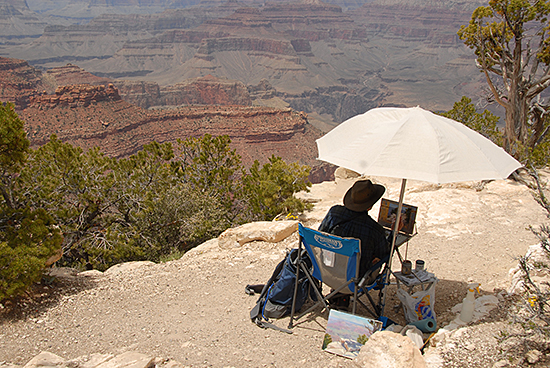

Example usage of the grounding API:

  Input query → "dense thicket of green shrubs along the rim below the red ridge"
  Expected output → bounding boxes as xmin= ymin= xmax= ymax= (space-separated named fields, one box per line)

xmin=1 ymin=124 xmax=311 ymax=270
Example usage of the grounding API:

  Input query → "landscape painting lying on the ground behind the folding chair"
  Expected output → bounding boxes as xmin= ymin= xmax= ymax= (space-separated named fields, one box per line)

xmin=323 ymin=309 xmax=382 ymax=359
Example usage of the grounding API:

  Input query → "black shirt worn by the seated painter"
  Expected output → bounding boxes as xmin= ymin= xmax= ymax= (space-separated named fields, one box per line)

xmin=319 ymin=205 xmax=390 ymax=275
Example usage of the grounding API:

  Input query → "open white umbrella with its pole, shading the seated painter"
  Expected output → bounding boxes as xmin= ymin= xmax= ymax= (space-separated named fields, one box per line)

xmin=317 ymin=107 xmax=522 ymax=316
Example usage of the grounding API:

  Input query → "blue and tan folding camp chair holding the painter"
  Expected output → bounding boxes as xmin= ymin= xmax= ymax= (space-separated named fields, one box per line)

xmin=289 ymin=224 xmax=388 ymax=328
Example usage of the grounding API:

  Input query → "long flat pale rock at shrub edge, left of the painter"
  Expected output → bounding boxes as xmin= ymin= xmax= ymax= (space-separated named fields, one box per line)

xmin=219 ymin=221 xmax=298 ymax=249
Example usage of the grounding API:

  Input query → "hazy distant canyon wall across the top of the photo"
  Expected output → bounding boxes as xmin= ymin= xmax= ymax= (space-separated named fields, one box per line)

xmin=3 ymin=0 xmax=496 ymax=130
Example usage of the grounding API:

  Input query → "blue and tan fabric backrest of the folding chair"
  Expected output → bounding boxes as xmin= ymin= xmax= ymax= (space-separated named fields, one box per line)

xmin=298 ymin=224 xmax=361 ymax=293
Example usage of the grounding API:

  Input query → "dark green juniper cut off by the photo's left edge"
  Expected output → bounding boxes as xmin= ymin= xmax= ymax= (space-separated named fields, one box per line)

xmin=0 ymin=104 xmax=62 ymax=300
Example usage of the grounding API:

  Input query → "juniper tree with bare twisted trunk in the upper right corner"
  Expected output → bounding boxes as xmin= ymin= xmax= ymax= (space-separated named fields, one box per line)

xmin=458 ymin=0 xmax=550 ymax=160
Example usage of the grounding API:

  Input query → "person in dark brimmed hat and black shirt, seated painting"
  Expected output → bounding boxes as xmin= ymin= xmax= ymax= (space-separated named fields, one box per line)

xmin=319 ymin=180 xmax=390 ymax=277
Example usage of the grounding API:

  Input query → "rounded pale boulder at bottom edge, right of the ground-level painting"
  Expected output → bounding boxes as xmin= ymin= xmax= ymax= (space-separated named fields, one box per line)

xmin=354 ymin=331 xmax=427 ymax=368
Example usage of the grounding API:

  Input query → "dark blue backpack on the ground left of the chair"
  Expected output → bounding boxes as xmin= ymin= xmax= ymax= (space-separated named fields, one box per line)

xmin=245 ymin=248 xmax=317 ymax=333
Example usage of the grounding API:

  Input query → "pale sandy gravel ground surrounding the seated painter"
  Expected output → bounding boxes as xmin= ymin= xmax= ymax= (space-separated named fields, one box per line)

xmin=0 ymin=171 xmax=548 ymax=367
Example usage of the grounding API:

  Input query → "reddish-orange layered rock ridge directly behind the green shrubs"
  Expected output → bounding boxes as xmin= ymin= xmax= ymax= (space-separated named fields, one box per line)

xmin=20 ymin=85 xmax=325 ymax=180
